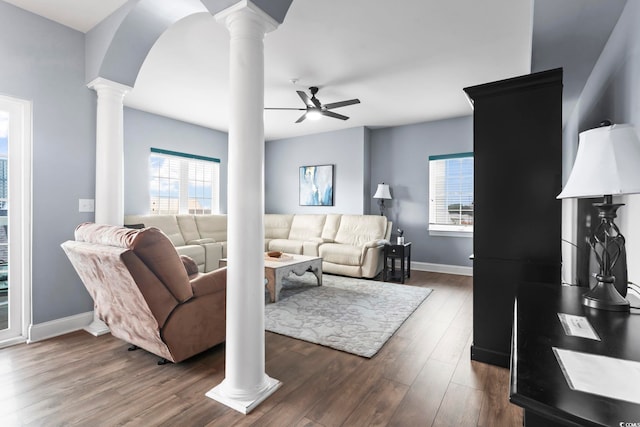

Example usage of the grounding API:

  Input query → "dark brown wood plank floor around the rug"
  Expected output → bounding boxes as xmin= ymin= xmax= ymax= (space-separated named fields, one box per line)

xmin=0 ymin=271 xmax=522 ymax=427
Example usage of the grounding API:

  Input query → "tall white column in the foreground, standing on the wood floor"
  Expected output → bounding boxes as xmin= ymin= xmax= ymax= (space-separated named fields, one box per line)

xmin=207 ymin=1 xmax=280 ymax=414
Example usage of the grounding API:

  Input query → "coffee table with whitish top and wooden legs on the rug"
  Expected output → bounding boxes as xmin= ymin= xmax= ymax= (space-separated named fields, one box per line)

xmin=219 ymin=254 xmax=322 ymax=302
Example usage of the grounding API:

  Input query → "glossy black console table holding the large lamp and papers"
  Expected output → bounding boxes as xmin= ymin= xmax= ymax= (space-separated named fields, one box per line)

xmin=510 ymin=284 xmax=640 ymax=427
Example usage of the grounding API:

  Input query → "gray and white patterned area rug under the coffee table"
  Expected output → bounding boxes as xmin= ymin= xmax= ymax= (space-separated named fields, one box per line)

xmin=265 ymin=273 xmax=432 ymax=358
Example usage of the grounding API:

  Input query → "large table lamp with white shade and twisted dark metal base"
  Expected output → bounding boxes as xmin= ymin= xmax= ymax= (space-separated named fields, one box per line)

xmin=558 ymin=121 xmax=640 ymax=311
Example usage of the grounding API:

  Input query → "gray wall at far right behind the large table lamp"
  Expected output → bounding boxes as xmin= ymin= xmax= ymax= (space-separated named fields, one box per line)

xmin=563 ymin=0 xmax=640 ymax=283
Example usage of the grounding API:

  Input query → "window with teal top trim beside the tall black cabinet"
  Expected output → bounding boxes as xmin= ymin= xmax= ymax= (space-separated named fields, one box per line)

xmin=429 ymin=153 xmax=473 ymax=234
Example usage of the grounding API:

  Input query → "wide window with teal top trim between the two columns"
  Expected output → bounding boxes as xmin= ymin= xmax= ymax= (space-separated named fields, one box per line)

xmin=149 ymin=148 xmax=220 ymax=214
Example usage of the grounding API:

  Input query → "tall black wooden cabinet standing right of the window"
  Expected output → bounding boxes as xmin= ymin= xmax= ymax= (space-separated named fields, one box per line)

xmin=464 ymin=69 xmax=562 ymax=367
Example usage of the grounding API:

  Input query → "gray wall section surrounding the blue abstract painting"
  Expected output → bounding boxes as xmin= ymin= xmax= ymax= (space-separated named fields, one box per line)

xmin=265 ymin=127 xmax=369 ymax=214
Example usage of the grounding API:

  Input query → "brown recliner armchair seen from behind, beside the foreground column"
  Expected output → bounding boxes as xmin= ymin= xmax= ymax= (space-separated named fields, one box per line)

xmin=61 ymin=223 xmax=227 ymax=363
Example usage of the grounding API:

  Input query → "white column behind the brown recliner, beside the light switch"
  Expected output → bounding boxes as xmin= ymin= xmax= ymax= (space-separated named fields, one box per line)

xmin=85 ymin=77 xmax=131 ymax=336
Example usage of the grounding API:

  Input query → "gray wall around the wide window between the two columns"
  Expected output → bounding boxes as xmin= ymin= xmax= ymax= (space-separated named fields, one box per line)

xmin=124 ymin=108 xmax=229 ymax=215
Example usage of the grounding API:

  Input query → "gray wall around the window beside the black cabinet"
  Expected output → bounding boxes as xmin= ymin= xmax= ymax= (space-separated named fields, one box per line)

xmin=369 ymin=116 xmax=473 ymax=266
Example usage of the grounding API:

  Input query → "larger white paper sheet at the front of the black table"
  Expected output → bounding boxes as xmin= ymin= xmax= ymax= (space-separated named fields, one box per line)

xmin=553 ymin=347 xmax=640 ymax=405
